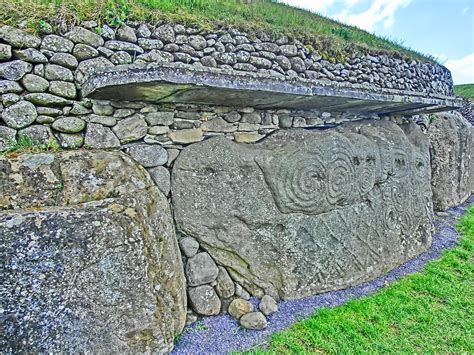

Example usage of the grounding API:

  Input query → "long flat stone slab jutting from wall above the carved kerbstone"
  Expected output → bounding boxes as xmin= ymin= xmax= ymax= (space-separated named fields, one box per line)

xmin=82 ymin=63 xmax=462 ymax=115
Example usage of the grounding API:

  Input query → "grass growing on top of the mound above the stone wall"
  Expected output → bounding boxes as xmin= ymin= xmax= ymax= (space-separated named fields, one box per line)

xmin=0 ymin=0 xmax=434 ymax=62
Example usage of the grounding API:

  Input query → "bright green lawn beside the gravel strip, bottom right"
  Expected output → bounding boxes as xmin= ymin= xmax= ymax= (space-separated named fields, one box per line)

xmin=255 ymin=206 xmax=474 ymax=354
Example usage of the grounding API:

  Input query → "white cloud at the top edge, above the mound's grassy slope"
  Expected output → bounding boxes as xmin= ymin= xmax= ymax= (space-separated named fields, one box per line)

xmin=336 ymin=0 xmax=411 ymax=32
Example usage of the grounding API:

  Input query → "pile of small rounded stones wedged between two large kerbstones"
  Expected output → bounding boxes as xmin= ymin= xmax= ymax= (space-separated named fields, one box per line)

xmin=179 ymin=236 xmax=278 ymax=329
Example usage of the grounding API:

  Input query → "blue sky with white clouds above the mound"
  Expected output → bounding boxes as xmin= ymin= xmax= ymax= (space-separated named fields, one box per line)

xmin=282 ymin=0 xmax=474 ymax=84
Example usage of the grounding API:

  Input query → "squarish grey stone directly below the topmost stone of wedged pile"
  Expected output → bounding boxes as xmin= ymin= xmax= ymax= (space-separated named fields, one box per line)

xmin=185 ymin=252 xmax=219 ymax=286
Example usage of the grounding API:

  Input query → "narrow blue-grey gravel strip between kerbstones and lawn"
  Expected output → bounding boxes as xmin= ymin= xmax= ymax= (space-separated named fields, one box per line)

xmin=173 ymin=195 xmax=474 ymax=354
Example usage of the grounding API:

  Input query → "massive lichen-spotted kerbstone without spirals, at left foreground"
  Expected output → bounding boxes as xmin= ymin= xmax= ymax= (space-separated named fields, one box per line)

xmin=0 ymin=151 xmax=186 ymax=353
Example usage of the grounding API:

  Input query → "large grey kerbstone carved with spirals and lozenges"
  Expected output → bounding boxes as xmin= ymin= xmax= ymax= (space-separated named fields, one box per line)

xmin=172 ymin=121 xmax=433 ymax=299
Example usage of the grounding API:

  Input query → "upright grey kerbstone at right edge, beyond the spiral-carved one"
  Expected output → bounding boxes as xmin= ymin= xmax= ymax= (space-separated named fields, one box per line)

xmin=428 ymin=112 xmax=474 ymax=210
